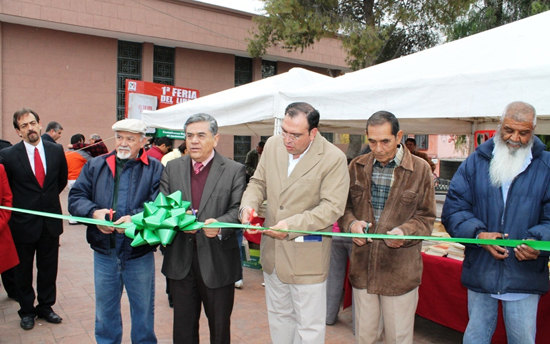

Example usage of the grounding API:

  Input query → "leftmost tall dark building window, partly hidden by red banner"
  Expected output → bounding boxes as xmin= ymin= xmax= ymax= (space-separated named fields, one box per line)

xmin=117 ymin=41 xmax=141 ymax=120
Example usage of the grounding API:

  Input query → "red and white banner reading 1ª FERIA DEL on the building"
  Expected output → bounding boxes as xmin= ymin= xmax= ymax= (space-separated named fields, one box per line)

xmin=124 ymin=79 xmax=199 ymax=118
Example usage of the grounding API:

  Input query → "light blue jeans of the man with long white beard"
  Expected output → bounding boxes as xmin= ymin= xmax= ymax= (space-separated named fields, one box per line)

xmin=463 ymin=290 xmax=540 ymax=344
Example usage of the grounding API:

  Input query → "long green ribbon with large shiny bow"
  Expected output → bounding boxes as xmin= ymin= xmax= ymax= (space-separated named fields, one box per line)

xmin=0 ymin=198 xmax=550 ymax=251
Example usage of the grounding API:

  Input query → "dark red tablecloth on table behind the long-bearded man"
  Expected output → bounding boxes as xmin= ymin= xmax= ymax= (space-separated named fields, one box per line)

xmin=416 ymin=254 xmax=550 ymax=344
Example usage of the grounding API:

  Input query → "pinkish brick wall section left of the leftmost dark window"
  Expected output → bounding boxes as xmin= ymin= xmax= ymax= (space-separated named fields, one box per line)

xmin=2 ymin=23 xmax=117 ymax=148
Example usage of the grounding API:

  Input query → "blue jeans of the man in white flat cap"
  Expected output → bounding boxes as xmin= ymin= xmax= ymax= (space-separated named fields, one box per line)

xmin=94 ymin=249 xmax=157 ymax=344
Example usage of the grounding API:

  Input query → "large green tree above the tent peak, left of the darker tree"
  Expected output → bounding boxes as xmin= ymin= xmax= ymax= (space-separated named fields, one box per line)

xmin=248 ymin=0 xmax=473 ymax=70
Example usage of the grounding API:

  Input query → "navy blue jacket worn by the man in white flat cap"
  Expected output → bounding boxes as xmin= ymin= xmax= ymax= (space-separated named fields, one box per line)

xmin=69 ymin=151 xmax=163 ymax=261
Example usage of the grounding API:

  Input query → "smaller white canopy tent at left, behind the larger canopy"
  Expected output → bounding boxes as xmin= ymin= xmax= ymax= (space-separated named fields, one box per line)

xmin=141 ymin=68 xmax=332 ymax=135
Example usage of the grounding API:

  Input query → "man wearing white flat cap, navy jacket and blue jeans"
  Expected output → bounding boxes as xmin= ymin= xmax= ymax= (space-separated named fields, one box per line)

xmin=69 ymin=119 xmax=163 ymax=344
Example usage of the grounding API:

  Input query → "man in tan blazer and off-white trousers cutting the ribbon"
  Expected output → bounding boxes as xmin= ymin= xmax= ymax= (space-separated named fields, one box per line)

xmin=240 ymin=103 xmax=349 ymax=343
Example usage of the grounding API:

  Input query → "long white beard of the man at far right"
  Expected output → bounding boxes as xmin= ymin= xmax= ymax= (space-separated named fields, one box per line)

xmin=489 ymin=131 xmax=534 ymax=187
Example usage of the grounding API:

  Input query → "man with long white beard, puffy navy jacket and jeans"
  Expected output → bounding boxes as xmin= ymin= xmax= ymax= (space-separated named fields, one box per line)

xmin=441 ymin=102 xmax=550 ymax=344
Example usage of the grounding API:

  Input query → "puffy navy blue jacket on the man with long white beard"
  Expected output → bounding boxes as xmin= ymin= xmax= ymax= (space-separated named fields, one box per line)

xmin=441 ymin=137 xmax=550 ymax=294
